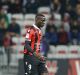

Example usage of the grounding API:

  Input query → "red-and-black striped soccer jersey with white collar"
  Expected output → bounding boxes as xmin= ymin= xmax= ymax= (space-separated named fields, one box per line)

xmin=26 ymin=24 xmax=42 ymax=53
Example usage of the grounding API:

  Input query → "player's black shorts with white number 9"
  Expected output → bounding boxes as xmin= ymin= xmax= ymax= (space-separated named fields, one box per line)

xmin=24 ymin=55 xmax=48 ymax=75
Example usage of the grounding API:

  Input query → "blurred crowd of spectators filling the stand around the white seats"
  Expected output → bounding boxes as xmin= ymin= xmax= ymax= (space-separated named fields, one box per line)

xmin=0 ymin=0 xmax=80 ymax=67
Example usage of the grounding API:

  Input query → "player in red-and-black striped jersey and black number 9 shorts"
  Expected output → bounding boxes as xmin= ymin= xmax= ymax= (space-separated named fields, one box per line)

xmin=24 ymin=14 xmax=48 ymax=75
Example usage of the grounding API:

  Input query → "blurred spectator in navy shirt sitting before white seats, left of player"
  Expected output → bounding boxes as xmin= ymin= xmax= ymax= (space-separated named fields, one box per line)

xmin=8 ymin=18 xmax=20 ymax=36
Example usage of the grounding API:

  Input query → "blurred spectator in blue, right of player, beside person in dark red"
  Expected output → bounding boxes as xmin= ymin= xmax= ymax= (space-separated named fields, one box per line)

xmin=45 ymin=28 xmax=58 ymax=45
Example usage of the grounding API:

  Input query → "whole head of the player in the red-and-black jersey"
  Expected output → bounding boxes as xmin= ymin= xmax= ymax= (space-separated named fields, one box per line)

xmin=35 ymin=14 xmax=45 ymax=28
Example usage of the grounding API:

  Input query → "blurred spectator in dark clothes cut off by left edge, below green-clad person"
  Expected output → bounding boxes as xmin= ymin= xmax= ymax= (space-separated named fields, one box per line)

xmin=0 ymin=18 xmax=7 ymax=46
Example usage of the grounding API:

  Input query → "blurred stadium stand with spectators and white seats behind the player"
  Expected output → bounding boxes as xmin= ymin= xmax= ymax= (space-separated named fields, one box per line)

xmin=0 ymin=0 xmax=80 ymax=75
